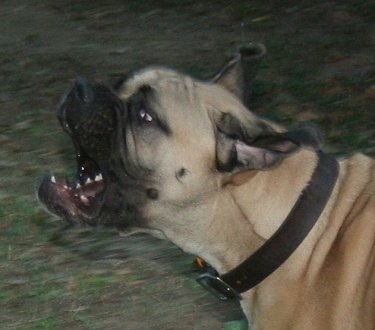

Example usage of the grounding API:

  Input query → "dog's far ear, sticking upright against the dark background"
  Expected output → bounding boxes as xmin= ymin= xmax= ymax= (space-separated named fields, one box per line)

xmin=211 ymin=43 xmax=266 ymax=107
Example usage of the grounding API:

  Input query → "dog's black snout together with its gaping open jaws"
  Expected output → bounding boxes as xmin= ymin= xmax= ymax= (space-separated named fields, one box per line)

xmin=38 ymin=78 xmax=121 ymax=225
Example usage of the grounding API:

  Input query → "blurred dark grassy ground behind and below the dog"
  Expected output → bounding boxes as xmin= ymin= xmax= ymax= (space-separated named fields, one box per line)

xmin=0 ymin=0 xmax=375 ymax=330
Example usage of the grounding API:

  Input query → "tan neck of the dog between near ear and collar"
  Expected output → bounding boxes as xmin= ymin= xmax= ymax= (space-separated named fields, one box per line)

xmin=205 ymin=150 xmax=317 ymax=273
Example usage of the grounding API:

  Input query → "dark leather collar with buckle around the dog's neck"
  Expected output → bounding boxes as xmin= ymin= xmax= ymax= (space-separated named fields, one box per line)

xmin=197 ymin=151 xmax=338 ymax=300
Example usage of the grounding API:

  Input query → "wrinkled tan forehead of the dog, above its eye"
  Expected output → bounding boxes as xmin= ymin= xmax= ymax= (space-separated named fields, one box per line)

xmin=118 ymin=68 xmax=258 ymax=132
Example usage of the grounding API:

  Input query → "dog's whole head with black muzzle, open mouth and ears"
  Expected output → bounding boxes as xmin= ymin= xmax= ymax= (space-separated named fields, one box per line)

xmin=38 ymin=53 xmax=317 ymax=237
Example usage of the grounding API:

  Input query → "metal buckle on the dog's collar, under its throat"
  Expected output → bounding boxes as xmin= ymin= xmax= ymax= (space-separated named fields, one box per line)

xmin=196 ymin=273 xmax=242 ymax=301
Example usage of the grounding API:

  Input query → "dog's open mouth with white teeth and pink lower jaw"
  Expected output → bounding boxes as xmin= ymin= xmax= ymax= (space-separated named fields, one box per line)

xmin=38 ymin=147 xmax=105 ymax=224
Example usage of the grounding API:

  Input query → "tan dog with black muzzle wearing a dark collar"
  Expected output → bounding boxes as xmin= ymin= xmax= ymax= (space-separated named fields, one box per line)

xmin=39 ymin=47 xmax=375 ymax=330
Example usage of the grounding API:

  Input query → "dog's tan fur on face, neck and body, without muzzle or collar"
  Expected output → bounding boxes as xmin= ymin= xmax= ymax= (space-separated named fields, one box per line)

xmin=116 ymin=69 xmax=375 ymax=330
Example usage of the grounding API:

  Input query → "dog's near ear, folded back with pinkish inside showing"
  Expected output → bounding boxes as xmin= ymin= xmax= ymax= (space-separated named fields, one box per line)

xmin=216 ymin=114 xmax=321 ymax=173
